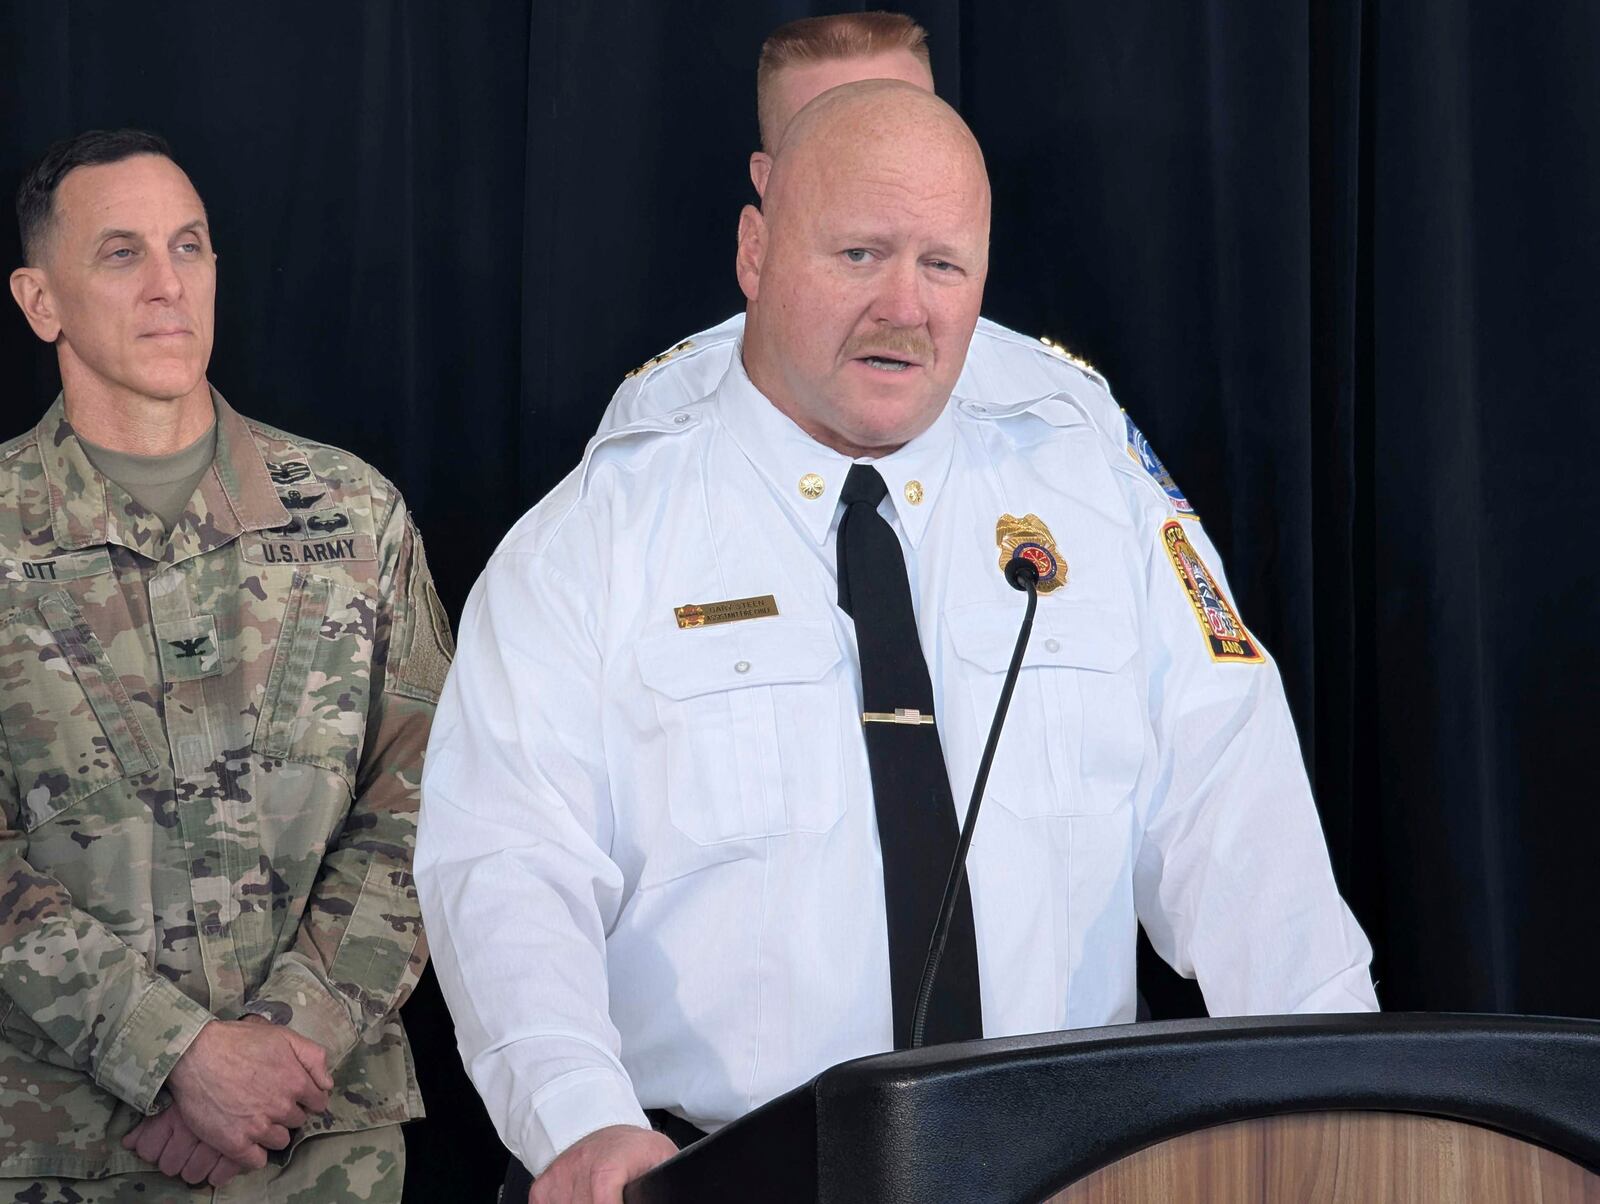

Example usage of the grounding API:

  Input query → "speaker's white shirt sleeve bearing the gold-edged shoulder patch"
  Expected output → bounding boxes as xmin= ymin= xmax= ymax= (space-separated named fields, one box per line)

xmin=1134 ymin=520 xmax=1378 ymax=1015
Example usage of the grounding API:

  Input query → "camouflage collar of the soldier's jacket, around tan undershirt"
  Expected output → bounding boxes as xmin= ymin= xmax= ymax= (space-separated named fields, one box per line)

xmin=35 ymin=389 xmax=290 ymax=562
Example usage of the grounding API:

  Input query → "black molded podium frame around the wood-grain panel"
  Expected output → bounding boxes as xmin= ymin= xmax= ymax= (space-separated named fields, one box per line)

xmin=624 ymin=1013 xmax=1600 ymax=1204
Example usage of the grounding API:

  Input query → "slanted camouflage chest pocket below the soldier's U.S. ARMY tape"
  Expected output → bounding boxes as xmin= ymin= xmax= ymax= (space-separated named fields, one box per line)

xmin=254 ymin=572 xmax=378 ymax=791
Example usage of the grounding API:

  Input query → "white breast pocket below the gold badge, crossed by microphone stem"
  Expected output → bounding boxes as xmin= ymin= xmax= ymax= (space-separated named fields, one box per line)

xmin=947 ymin=597 xmax=1146 ymax=818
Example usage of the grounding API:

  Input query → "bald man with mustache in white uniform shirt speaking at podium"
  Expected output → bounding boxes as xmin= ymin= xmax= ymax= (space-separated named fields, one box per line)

xmin=416 ymin=80 xmax=1376 ymax=1201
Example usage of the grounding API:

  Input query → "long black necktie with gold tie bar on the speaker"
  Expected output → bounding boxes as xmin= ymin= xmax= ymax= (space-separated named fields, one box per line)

xmin=838 ymin=464 xmax=984 ymax=1049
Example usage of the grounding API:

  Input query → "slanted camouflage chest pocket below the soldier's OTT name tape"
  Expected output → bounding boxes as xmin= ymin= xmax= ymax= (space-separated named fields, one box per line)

xmin=0 ymin=589 xmax=155 ymax=831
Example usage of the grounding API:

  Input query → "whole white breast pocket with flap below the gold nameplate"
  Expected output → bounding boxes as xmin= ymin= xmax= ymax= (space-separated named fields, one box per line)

xmin=637 ymin=618 xmax=848 ymax=844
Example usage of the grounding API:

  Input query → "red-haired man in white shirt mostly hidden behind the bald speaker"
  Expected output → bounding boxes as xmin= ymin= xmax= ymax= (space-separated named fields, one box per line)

xmin=600 ymin=13 xmax=1139 ymax=443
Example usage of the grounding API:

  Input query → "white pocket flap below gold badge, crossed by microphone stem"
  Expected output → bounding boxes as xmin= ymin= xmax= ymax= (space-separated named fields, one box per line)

xmin=946 ymin=594 xmax=1139 ymax=672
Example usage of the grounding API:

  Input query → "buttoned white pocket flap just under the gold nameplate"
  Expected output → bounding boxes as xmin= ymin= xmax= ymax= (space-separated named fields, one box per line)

xmin=638 ymin=618 xmax=840 ymax=701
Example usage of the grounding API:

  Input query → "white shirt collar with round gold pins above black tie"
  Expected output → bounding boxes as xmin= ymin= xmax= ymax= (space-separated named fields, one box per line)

xmin=715 ymin=343 xmax=955 ymax=548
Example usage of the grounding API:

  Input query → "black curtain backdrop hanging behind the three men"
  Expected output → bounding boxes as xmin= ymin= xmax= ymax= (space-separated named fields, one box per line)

xmin=0 ymin=0 xmax=1600 ymax=1199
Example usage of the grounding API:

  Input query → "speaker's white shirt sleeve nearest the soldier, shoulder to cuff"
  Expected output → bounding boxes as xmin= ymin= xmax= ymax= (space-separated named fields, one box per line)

xmin=416 ymin=541 xmax=646 ymax=1174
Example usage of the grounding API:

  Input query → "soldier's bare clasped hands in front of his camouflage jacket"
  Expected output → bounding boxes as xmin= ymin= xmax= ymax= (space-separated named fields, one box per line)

xmin=122 ymin=1017 xmax=333 ymax=1188
